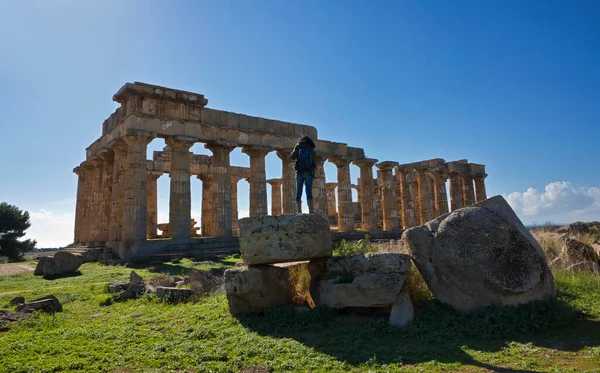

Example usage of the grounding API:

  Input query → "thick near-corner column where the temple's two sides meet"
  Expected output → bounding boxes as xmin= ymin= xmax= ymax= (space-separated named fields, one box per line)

xmin=122 ymin=133 xmax=152 ymax=241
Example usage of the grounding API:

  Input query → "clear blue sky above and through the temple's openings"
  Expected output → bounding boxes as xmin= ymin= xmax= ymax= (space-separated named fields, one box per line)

xmin=0 ymin=0 xmax=600 ymax=246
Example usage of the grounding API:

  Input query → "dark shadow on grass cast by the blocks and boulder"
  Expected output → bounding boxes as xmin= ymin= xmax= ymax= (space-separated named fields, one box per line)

xmin=239 ymin=294 xmax=600 ymax=372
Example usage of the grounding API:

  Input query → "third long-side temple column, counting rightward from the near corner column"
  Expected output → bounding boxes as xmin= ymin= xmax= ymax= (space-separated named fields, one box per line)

xmin=205 ymin=142 xmax=235 ymax=237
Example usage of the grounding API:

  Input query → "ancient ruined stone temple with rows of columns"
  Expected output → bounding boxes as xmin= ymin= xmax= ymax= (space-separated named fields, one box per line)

xmin=74 ymin=82 xmax=486 ymax=258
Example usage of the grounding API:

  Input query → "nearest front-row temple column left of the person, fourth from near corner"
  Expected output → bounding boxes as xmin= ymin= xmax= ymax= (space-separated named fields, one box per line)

xmin=241 ymin=146 xmax=272 ymax=217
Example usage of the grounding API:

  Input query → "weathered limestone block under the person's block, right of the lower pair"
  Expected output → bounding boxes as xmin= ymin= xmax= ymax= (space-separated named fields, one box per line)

xmin=313 ymin=253 xmax=410 ymax=308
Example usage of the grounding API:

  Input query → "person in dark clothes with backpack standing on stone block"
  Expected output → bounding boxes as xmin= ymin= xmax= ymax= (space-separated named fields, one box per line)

xmin=290 ymin=136 xmax=317 ymax=214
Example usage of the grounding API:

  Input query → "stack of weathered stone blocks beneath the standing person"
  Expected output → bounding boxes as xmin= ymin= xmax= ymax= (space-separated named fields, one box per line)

xmin=224 ymin=214 xmax=413 ymax=326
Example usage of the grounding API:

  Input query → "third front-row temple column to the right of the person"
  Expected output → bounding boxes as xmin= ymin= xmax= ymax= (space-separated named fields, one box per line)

xmin=353 ymin=158 xmax=377 ymax=231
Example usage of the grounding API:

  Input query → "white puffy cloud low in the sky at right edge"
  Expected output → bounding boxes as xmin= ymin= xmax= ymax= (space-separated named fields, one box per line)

xmin=504 ymin=181 xmax=600 ymax=223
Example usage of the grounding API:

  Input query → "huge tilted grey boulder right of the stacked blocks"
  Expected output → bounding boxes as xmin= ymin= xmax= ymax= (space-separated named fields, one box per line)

xmin=402 ymin=196 xmax=556 ymax=311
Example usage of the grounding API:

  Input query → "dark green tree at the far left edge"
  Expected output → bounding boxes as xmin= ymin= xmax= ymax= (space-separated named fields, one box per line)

xmin=0 ymin=202 xmax=37 ymax=260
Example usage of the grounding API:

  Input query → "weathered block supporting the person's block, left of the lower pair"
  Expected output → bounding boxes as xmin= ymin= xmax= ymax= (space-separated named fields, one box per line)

xmin=224 ymin=265 xmax=294 ymax=315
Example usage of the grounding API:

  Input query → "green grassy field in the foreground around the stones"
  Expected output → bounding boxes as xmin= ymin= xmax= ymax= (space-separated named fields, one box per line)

xmin=0 ymin=259 xmax=600 ymax=372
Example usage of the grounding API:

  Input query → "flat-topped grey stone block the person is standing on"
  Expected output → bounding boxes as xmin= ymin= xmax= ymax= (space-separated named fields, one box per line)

xmin=239 ymin=214 xmax=332 ymax=265
